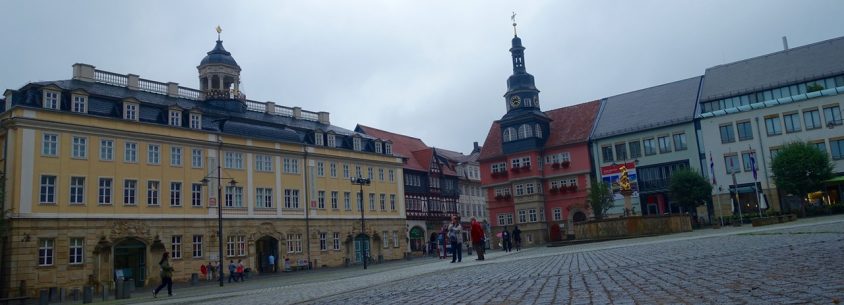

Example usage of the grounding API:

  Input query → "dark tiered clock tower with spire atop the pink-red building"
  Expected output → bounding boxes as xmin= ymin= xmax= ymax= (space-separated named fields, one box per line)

xmin=499 ymin=18 xmax=551 ymax=154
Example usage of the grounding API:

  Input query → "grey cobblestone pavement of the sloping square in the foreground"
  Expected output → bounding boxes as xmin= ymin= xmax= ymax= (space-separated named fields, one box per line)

xmin=134 ymin=216 xmax=844 ymax=304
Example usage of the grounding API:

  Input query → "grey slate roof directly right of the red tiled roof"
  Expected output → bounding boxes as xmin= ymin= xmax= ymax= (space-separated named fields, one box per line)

xmin=592 ymin=76 xmax=701 ymax=139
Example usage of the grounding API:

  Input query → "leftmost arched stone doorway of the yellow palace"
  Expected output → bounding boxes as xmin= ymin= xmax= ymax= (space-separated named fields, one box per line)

xmin=114 ymin=238 xmax=147 ymax=287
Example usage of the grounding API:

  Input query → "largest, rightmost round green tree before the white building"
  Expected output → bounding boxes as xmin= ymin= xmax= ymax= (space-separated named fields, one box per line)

xmin=771 ymin=142 xmax=835 ymax=208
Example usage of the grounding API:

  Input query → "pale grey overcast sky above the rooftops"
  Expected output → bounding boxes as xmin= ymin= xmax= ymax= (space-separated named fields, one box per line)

xmin=0 ymin=0 xmax=844 ymax=153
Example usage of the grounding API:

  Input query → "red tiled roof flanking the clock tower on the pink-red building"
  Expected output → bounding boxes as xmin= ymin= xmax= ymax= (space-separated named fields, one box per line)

xmin=478 ymin=100 xmax=601 ymax=160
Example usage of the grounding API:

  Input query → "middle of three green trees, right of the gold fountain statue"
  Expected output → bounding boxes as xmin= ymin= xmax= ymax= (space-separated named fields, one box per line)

xmin=668 ymin=168 xmax=712 ymax=211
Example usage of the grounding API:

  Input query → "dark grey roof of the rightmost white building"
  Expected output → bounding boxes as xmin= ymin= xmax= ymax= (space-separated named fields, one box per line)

xmin=700 ymin=37 xmax=844 ymax=102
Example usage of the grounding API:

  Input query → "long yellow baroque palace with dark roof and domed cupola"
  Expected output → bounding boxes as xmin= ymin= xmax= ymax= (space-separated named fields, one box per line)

xmin=0 ymin=36 xmax=408 ymax=296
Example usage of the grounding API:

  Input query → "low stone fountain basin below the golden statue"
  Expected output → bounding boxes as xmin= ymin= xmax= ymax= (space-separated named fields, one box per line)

xmin=574 ymin=215 xmax=692 ymax=240
